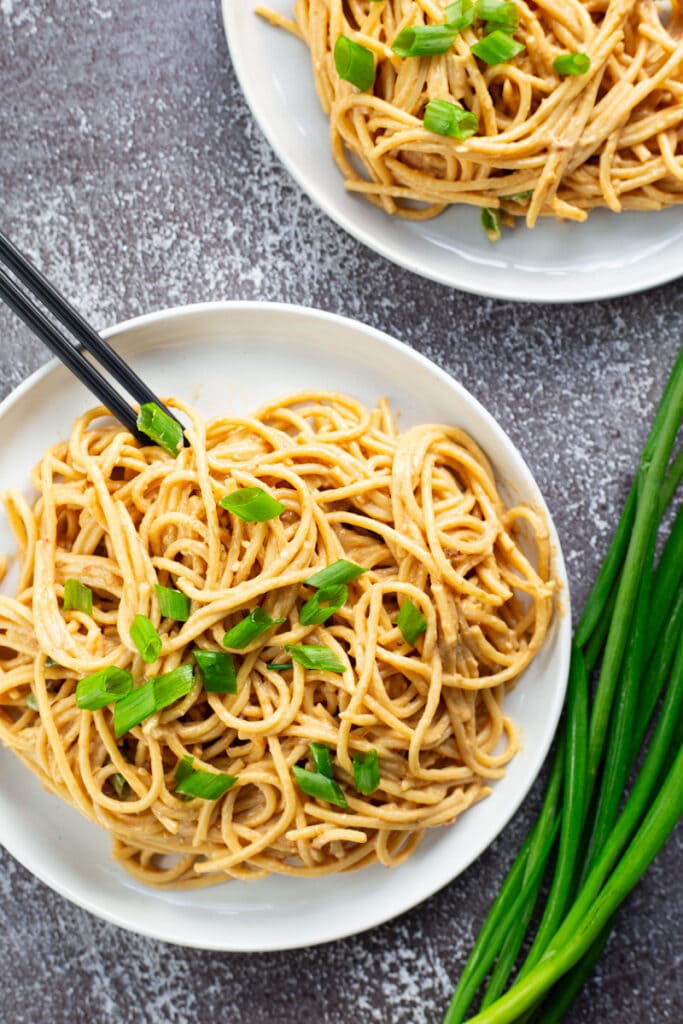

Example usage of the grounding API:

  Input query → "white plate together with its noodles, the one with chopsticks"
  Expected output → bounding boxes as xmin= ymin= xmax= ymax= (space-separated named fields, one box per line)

xmin=0 ymin=302 xmax=570 ymax=951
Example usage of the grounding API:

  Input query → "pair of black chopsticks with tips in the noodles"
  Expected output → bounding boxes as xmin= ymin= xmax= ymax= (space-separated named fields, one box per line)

xmin=0 ymin=231 xmax=182 ymax=444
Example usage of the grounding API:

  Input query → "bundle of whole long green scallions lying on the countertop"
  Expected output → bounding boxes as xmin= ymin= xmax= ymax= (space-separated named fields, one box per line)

xmin=443 ymin=348 xmax=683 ymax=1024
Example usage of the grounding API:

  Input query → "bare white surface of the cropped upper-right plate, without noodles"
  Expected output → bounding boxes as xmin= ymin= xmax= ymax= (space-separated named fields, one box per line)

xmin=222 ymin=0 xmax=683 ymax=302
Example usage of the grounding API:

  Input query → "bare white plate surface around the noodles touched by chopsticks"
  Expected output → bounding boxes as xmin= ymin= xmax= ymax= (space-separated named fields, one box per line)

xmin=0 ymin=303 xmax=570 ymax=950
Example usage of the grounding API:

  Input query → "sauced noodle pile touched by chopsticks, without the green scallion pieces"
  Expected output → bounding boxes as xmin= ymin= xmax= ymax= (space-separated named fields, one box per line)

xmin=0 ymin=392 xmax=554 ymax=886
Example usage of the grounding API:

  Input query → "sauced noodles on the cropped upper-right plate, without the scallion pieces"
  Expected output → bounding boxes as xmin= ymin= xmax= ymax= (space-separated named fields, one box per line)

xmin=258 ymin=0 xmax=683 ymax=227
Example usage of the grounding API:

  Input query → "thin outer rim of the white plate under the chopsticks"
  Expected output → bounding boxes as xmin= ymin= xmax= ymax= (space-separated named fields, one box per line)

xmin=0 ymin=300 xmax=571 ymax=953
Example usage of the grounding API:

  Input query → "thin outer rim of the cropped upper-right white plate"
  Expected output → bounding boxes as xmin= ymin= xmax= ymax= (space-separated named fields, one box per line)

xmin=221 ymin=0 xmax=683 ymax=305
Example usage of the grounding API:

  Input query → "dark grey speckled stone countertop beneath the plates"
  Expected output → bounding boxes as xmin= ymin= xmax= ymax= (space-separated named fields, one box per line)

xmin=0 ymin=0 xmax=683 ymax=1024
